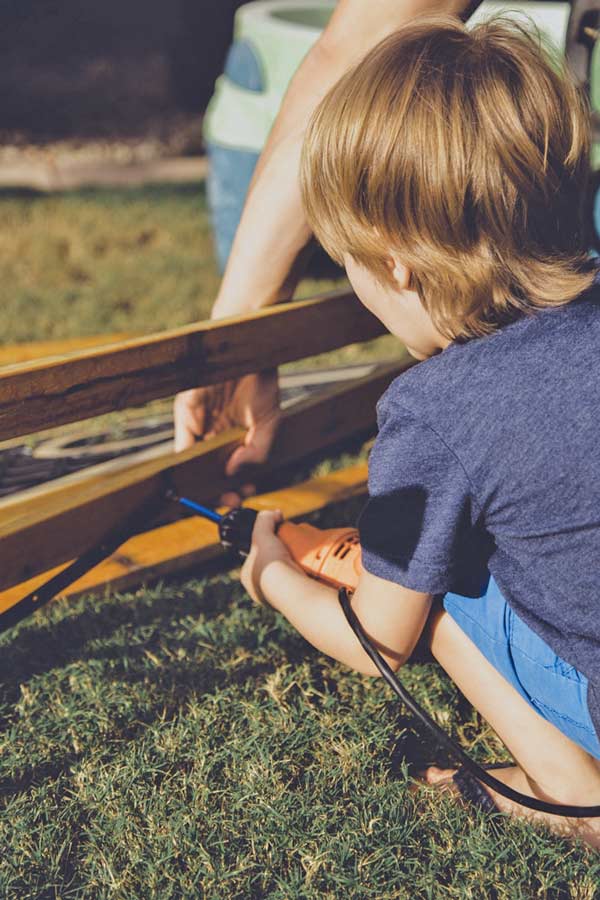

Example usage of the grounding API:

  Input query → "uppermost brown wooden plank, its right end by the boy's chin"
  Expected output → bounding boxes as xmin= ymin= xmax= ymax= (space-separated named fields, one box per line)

xmin=0 ymin=291 xmax=384 ymax=441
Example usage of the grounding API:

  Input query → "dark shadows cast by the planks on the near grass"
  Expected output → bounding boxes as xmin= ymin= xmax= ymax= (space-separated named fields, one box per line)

xmin=0 ymin=572 xmax=273 ymax=802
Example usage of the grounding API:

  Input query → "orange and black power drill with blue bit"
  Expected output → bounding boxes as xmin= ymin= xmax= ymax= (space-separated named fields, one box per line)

xmin=169 ymin=493 xmax=362 ymax=591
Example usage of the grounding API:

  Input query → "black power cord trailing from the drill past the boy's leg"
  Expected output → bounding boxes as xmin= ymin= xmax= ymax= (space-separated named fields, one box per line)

xmin=338 ymin=587 xmax=600 ymax=819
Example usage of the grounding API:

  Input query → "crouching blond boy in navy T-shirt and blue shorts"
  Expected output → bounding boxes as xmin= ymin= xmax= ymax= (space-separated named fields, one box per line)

xmin=242 ymin=17 xmax=600 ymax=847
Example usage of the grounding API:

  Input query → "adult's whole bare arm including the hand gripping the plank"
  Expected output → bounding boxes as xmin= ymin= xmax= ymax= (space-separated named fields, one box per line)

xmin=175 ymin=0 xmax=466 ymax=464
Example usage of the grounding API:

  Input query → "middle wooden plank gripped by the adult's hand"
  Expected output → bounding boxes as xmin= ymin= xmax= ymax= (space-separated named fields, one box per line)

xmin=0 ymin=357 xmax=412 ymax=590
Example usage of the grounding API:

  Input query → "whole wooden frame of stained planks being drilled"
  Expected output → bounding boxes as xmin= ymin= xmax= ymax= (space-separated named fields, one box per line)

xmin=0 ymin=291 xmax=413 ymax=628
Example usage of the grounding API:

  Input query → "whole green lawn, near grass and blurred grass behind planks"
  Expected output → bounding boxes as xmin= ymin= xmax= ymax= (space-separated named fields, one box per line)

xmin=0 ymin=187 xmax=600 ymax=900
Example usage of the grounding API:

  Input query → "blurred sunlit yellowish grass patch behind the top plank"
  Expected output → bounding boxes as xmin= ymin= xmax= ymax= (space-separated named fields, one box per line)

xmin=0 ymin=185 xmax=218 ymax=342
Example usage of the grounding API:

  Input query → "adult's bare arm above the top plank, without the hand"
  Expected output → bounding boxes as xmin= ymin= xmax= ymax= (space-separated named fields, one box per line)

xmin=213 ymin=0 xmax=464 ymax=318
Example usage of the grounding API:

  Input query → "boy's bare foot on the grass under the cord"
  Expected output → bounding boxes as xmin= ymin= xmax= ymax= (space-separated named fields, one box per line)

xmin=419 ymin=766 xmax=600 ymax=850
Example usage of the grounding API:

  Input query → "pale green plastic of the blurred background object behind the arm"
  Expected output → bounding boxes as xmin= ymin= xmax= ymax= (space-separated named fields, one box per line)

xmin=204 ymin=0 xmax=600 ymax=156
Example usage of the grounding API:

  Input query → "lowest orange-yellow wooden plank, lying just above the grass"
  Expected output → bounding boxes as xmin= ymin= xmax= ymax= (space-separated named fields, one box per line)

xmin=0 ymin=463 xmax=367 ymax=615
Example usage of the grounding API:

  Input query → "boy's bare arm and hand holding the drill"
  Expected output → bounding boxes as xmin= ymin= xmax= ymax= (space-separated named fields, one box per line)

xmin=242 ymin=512 xmax=432 ymax=675
